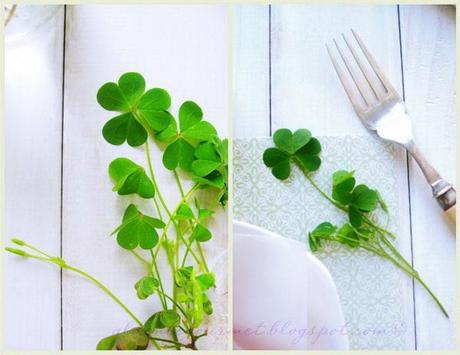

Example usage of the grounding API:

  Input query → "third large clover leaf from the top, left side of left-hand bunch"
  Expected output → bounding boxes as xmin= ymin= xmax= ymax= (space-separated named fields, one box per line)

xmin=112 ymin=204 xmax=165 ymax=250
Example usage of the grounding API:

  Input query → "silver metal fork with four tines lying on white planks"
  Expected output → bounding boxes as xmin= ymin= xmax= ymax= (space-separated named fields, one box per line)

xmin=326 ymin=30 xmax=456 ymax=223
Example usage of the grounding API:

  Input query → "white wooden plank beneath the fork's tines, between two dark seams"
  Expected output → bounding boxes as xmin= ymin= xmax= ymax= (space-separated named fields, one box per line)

xmin=271 ymin=5 xmax=414 ymax=349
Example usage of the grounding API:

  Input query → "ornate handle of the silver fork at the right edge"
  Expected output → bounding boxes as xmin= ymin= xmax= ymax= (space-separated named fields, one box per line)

xmin=404 ymin=141 xmax=457 ymax=223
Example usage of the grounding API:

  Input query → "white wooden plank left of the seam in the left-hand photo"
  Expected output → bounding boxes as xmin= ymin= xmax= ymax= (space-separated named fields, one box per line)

xmin=4 ymin=8 xmax=64 ymax=350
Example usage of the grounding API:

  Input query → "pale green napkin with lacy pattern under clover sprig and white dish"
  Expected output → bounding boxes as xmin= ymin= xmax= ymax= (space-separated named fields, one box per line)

xmin=233 ymin=137 xmax=413 ymax=349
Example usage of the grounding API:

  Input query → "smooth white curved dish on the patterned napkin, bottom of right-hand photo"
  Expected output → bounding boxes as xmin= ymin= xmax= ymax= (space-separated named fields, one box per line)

xmin=233 ymin=221 xmax=348 ymax=350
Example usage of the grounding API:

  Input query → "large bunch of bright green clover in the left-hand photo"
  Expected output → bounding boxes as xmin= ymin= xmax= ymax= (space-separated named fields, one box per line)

xmin=7 ymin=72 xmax=228 ymax=350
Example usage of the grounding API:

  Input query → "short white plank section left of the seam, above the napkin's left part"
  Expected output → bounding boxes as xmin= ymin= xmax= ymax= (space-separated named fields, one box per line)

xmin=232 ymin=5 xmax=270 ymax=137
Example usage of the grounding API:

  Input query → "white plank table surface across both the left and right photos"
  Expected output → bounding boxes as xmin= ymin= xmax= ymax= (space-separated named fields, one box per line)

xmin=5 ymin=5 xmax=456 ymax=350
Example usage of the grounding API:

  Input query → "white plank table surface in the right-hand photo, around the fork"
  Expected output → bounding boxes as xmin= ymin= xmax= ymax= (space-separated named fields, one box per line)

xmin=232 ymin=5 xmax=456 ymax=350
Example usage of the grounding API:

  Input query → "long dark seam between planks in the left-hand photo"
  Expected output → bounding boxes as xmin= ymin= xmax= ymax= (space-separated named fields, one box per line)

xmin=59 ymin=5 xmax=67 ymax=350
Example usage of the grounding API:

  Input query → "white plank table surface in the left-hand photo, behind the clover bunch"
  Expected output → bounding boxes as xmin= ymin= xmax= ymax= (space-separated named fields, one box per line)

xmin=5 ymin=5 xmax=229 ymax=350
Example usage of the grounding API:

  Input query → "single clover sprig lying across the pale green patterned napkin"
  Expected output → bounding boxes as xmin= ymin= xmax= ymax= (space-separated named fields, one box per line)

xmin=263 ymin=128 xmax=448 ymax=317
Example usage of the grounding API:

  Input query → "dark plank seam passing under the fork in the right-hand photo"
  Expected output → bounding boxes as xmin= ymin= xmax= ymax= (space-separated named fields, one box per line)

xmin=396 ymin=5 xmax=418 ymax=350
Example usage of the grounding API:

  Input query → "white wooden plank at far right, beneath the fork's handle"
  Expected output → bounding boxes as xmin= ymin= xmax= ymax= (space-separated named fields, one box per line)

xmin=400 ymin=6 xmax=456 ymax=350
